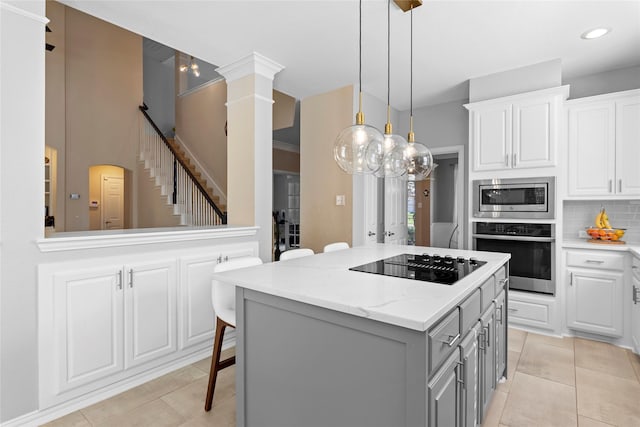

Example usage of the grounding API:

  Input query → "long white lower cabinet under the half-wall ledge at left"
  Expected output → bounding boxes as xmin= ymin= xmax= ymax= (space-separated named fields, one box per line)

xmin=38 ymin=242 xmax=258 ymax=409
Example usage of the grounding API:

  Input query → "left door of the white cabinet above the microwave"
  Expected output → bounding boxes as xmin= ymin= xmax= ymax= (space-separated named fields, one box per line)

xmin=471 ymin=104 xmax=512 ymax=171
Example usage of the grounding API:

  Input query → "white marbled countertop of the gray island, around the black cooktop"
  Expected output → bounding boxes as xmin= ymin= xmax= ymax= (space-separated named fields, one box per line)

xmin=214 ymin=244 xmax=511 ymax=331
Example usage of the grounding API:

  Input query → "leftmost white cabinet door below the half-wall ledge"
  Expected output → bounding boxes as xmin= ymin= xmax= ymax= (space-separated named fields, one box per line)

xmin=51 ymin=266 xmax=124 ymax=393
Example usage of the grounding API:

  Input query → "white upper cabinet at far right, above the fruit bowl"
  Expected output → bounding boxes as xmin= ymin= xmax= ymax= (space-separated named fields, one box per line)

xmin=567 ymin=90 xmax=640 ymax=198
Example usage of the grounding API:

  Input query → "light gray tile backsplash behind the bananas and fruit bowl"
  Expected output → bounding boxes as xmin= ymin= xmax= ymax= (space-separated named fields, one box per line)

xmin=563 ymin=200 xmax=640 ymax=243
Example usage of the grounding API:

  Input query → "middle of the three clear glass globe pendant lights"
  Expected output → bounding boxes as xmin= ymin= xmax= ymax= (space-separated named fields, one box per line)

xmin=374 ymin=0 xmax=408 ymax=178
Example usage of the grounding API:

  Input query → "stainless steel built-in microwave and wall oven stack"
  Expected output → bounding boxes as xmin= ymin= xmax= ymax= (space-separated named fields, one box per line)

xmin=472 ymin=177 xmax=555 ymax=295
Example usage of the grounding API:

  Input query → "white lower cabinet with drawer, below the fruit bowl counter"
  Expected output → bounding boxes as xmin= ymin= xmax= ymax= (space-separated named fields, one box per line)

xmin=567 ymin=250 xmax=625 ymax=337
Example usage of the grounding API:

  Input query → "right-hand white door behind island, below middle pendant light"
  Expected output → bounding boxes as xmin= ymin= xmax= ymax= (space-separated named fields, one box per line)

xmin=384 ymin=178 xmax=408 ymax=245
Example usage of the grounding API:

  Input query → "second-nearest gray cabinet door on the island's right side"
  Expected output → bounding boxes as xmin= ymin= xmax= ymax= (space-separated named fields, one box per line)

xmin=460 ymin=328 xmax=478 ymax=427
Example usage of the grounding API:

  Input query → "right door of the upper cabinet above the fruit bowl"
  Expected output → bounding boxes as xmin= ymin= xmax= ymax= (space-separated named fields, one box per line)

xmin=616 ymin=96 xmax=640 ymax=196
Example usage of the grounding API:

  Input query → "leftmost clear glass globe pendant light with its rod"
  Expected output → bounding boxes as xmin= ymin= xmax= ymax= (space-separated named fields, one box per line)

xmin=333 ymin=0 xmax=384 ymax=174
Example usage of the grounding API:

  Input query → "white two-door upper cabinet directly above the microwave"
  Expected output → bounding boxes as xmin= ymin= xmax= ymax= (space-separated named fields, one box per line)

xmin=466 ymin=86 xmax=568 ymax=172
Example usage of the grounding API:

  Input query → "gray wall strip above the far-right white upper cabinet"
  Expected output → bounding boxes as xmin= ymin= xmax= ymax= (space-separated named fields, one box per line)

xmin=562 ymin=67 xmax=640 ymax=99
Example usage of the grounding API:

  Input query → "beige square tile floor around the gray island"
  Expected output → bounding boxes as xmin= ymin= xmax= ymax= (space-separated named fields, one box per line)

xmin=46 ymin=329 xmax=640 ymax=427
